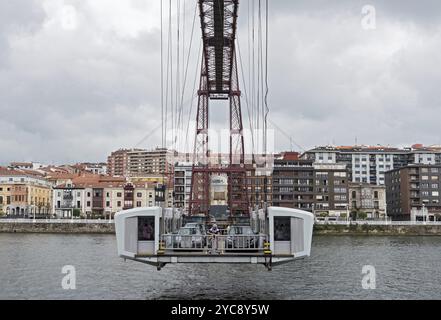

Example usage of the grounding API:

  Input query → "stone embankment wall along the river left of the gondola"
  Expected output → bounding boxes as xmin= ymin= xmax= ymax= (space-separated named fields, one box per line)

xmin=0 ymin=221 xmax=115 ymax=234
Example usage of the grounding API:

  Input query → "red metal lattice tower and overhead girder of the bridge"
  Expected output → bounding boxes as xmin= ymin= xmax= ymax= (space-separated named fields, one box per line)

xmin=189 ymin=0 xmax=249 ymax=216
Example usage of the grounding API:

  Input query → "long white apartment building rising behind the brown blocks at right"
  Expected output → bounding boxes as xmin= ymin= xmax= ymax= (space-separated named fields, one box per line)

xmin=302 ymin=145 xmax=441 ymax=185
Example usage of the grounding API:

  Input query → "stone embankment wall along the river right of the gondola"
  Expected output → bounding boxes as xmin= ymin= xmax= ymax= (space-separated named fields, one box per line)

xmin=314 ymin=224 xmax=441 ymax=236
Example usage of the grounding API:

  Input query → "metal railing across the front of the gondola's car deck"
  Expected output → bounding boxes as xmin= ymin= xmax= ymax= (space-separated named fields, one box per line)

xmin=161 ymin=234 xmax=267 ymax=254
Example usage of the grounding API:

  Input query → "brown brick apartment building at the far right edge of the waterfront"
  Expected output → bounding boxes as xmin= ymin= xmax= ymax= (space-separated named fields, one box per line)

xmin=386 ymin=164 xmax=441 ymax=221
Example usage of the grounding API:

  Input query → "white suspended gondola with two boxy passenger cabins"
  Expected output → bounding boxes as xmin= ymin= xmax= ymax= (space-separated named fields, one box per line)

xmin=115 ymin=207 xmax=314 ymax=269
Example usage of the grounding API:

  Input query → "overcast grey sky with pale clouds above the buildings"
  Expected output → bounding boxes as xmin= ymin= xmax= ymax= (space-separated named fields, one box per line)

xmin=0 ymin=0 xmax=441 ymax=164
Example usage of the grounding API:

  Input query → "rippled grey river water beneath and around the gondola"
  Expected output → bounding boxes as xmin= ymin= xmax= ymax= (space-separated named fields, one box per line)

xmin=0 ymin=234 xmax=441 ymax=300
